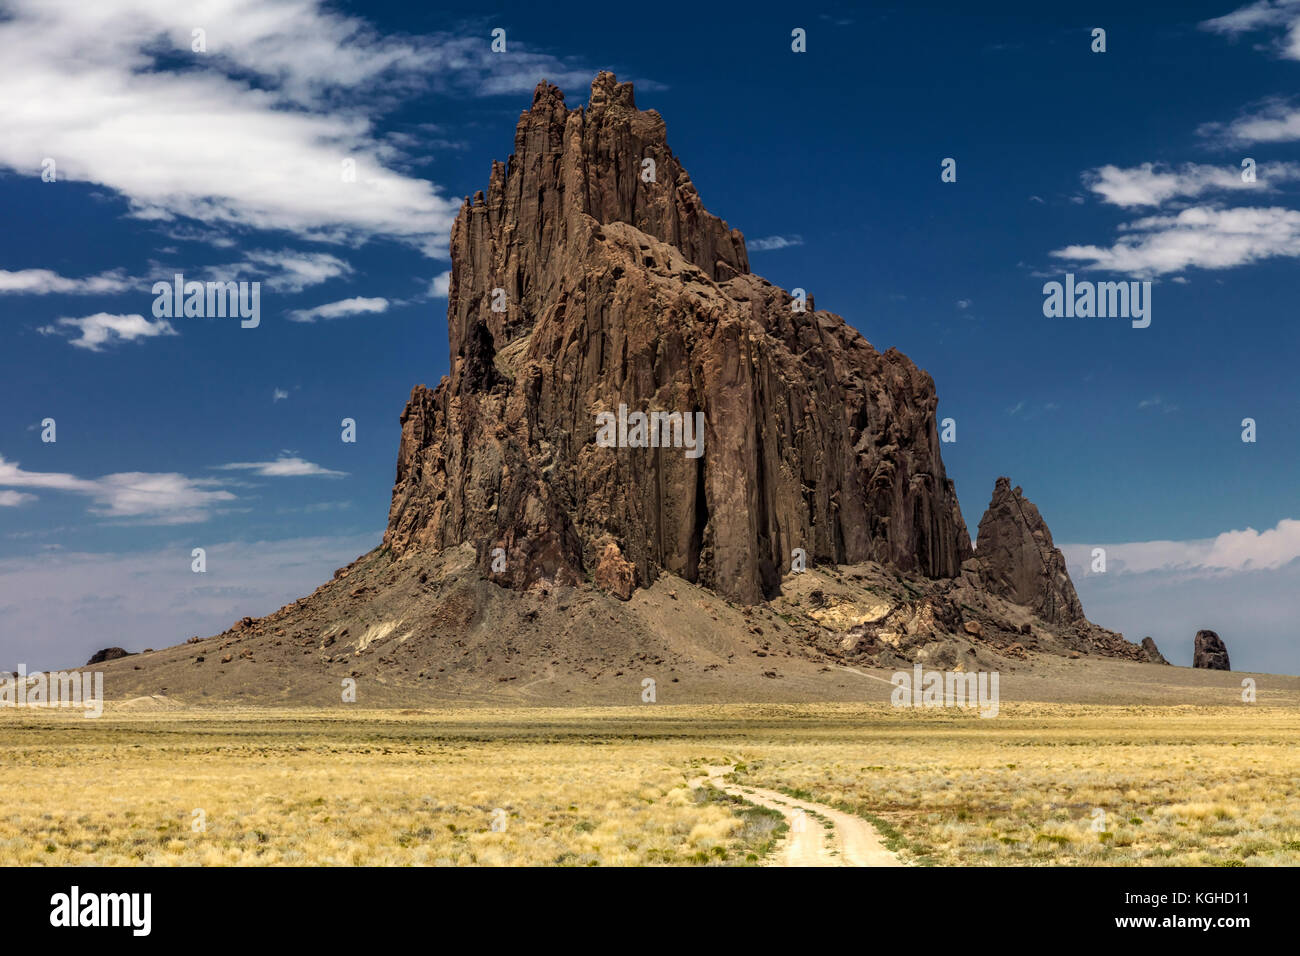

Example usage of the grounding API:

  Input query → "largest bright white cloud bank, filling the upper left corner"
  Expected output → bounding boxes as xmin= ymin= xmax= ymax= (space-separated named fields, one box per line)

xmin=0 ymin=0 xmax=462 ymax=255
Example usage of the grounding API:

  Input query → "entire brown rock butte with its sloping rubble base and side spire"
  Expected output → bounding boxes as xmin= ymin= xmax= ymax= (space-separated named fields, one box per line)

xmin=94 ymin=73 xmax=1151 ymax=705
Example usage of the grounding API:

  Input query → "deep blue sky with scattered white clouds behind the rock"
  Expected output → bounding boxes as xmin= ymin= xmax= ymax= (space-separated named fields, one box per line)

xmin=0 ymin=0 xmax=1300 ymax=672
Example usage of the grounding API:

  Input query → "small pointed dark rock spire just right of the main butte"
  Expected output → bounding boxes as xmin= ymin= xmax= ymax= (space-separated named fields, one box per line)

xmin=975 ymin=477 xmax=1083 ymax=624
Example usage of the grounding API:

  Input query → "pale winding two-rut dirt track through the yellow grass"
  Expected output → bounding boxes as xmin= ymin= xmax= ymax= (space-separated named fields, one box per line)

xmin=690 ymin=766 xmax=906 ymax=866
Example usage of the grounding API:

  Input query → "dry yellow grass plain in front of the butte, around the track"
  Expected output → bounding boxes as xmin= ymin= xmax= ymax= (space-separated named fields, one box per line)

xmin=0 ymin=704 xmax=1300 ymax=865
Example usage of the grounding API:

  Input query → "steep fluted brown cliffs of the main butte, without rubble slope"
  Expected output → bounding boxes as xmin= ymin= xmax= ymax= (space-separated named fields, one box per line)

xmin=384 ymin=73 xmax=972 ymax=604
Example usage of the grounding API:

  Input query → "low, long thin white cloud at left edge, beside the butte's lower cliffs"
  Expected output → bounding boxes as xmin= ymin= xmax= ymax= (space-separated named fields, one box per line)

xmin=0 ymin=457 xmax=235 ymax=524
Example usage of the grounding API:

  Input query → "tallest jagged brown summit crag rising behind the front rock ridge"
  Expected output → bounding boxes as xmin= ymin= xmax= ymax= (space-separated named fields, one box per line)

xmin=449 ymin=73 xmax=749 ymax=366
